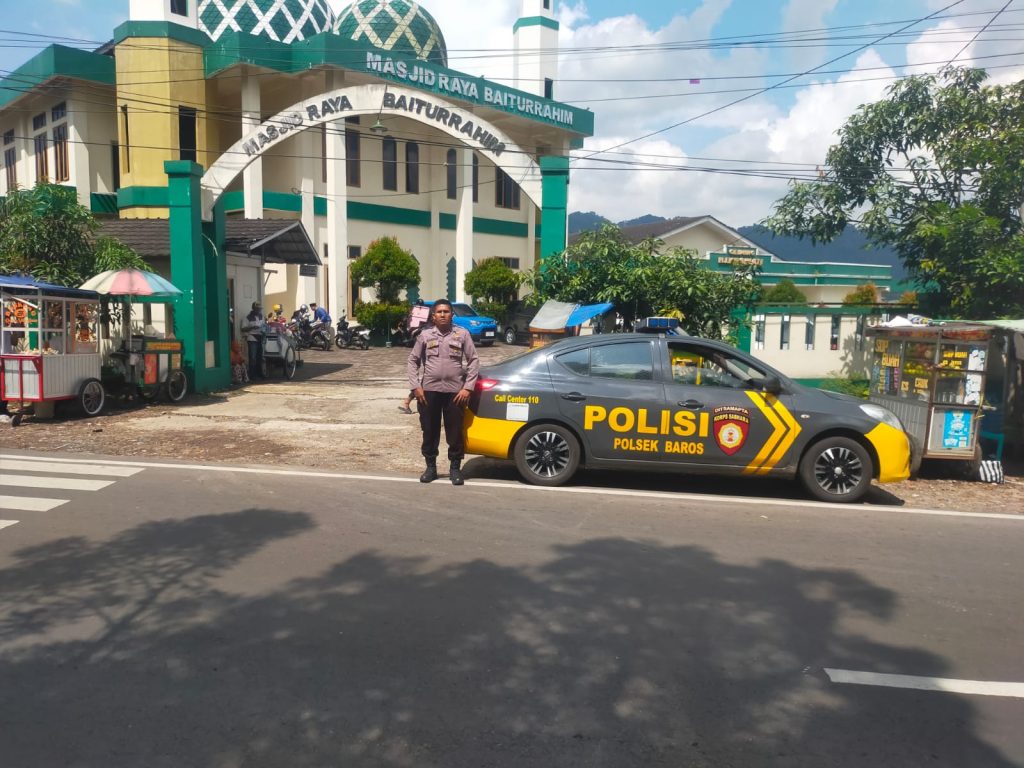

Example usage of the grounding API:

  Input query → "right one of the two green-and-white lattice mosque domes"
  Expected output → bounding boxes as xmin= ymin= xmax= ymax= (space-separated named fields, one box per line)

xmin=334 ymin=0 xmax=447 ymax=67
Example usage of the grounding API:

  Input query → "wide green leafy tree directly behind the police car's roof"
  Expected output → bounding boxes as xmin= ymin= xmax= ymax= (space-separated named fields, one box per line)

xmin=527 ymin=224 xmax=759 ymax=338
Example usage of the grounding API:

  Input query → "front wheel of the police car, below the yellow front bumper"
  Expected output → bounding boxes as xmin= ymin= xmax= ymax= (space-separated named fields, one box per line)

xmin=800 ymin=436 xmax=874 ymax=504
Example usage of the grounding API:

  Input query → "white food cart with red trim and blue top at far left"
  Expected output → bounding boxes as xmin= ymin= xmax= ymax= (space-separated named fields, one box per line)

xmin=0 ymin=275 xmax=106 ymax=425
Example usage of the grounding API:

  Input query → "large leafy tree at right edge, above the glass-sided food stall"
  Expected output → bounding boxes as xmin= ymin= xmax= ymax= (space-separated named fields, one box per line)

xmin=764 ymin=68 xmax=1024 ymax=317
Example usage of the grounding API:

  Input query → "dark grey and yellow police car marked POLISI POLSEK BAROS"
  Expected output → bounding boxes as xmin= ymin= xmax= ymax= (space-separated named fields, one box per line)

xmin=465 ymin=333 xmax=910 ymax=502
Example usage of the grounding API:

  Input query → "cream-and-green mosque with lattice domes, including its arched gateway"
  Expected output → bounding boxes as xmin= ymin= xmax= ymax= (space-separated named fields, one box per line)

xmin=0 ymin=0 xmax=594 ymax=385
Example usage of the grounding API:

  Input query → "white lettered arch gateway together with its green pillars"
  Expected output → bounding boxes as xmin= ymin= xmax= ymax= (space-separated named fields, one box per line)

xmin=164 ymin=84 xmax=568 ymax=392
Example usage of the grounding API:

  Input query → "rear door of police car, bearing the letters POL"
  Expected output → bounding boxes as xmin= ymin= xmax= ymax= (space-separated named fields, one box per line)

xmin=548 ymin=338 xmax=665 ymax=462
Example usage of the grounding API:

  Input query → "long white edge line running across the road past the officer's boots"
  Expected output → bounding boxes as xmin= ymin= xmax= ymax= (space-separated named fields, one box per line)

xmin=0 ymin=455 xmax=1024 ymax=522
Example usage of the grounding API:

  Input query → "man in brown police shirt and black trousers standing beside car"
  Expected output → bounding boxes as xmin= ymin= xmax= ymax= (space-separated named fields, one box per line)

xmin=407 ymin=299 xmax=480 ymax=485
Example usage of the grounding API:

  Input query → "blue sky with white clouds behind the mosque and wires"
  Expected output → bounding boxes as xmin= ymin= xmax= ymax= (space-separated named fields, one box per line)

xmin=0 ymin=0 xmax=1024 ymax=227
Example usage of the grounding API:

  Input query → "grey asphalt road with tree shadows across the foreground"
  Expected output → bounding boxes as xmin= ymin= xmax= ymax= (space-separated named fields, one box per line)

xmin=0 ymin=450 xmax=1024 ymax=768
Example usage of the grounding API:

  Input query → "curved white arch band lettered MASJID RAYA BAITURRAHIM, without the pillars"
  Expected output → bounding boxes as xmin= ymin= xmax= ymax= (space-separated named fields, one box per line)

xmin=202 ymin=84 xmax=544 ymax=219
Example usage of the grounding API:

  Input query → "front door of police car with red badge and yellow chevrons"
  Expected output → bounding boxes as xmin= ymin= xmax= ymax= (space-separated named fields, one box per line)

xmin=660 ymin=338 xmax=801 ymax=474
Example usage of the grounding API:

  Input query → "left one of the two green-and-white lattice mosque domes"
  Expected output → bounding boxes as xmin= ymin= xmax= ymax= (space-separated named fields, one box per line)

xmin=198 ymin=0 xmax=334 ymax=43
